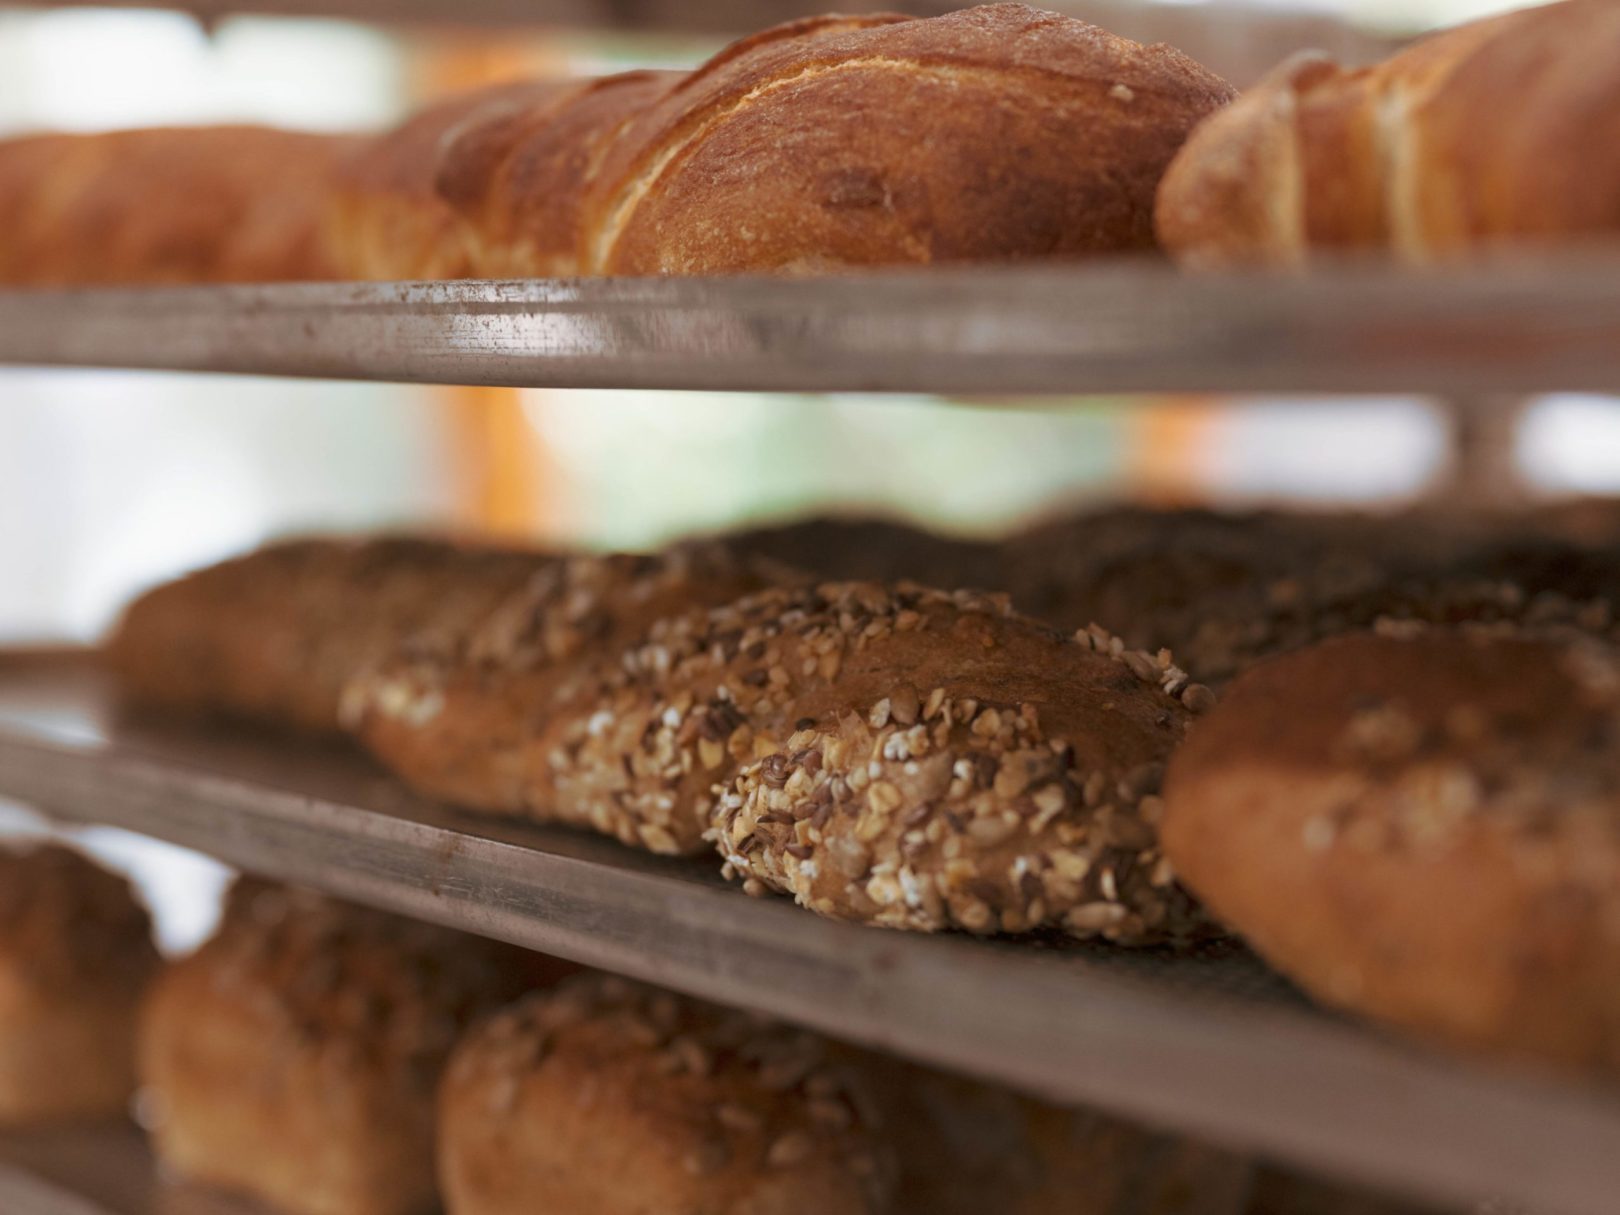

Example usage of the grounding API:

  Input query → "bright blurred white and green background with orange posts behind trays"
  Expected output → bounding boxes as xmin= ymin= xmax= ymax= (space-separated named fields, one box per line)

xmin=0 ymin=0 xmax=1620 ymax=944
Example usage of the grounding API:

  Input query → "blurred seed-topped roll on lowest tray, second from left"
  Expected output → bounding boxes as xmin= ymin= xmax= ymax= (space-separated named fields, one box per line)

xmin=139 ymin=883 xmax=572 ymax=1215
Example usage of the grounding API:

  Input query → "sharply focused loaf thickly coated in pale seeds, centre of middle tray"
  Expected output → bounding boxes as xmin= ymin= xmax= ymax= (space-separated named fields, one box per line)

xmin=583 ymin=583 xmax=1209 ymax=941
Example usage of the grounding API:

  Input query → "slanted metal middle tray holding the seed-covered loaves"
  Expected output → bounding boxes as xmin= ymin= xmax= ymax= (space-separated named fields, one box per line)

xmin=0 ymin=653 xmax=1620 ymax=1215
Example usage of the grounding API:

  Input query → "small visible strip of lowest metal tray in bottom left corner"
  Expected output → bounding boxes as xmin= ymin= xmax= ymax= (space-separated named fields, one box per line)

xmin=0 ymin=1123 xmax=264 ymax=1215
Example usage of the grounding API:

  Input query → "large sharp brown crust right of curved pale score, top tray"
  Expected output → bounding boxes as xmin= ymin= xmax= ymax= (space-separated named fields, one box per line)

xmin=585 ymin=5 xmax=1233 ymax=274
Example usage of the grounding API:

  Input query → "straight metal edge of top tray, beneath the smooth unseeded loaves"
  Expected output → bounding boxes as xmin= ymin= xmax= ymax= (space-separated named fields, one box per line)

xmin=0 ymin=256 xmax=1620 ymax=397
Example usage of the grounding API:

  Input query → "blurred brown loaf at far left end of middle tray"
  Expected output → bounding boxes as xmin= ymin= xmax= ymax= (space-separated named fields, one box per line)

xmin=107 ymin=538 xmax=549 ymax=732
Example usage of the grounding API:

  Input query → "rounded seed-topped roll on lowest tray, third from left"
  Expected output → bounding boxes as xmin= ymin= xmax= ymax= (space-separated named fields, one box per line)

xmin=439 ymin=975 xmax=894 ymax=1215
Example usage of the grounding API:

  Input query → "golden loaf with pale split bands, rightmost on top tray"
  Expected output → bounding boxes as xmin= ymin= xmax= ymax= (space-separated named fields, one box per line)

xmin=1157 ymin=0 xmax=1620 ymax=266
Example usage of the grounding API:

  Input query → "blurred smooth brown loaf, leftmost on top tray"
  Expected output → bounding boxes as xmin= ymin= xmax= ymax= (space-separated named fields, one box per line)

xmin=0 ymin=126 xmax=356 ymax=287
